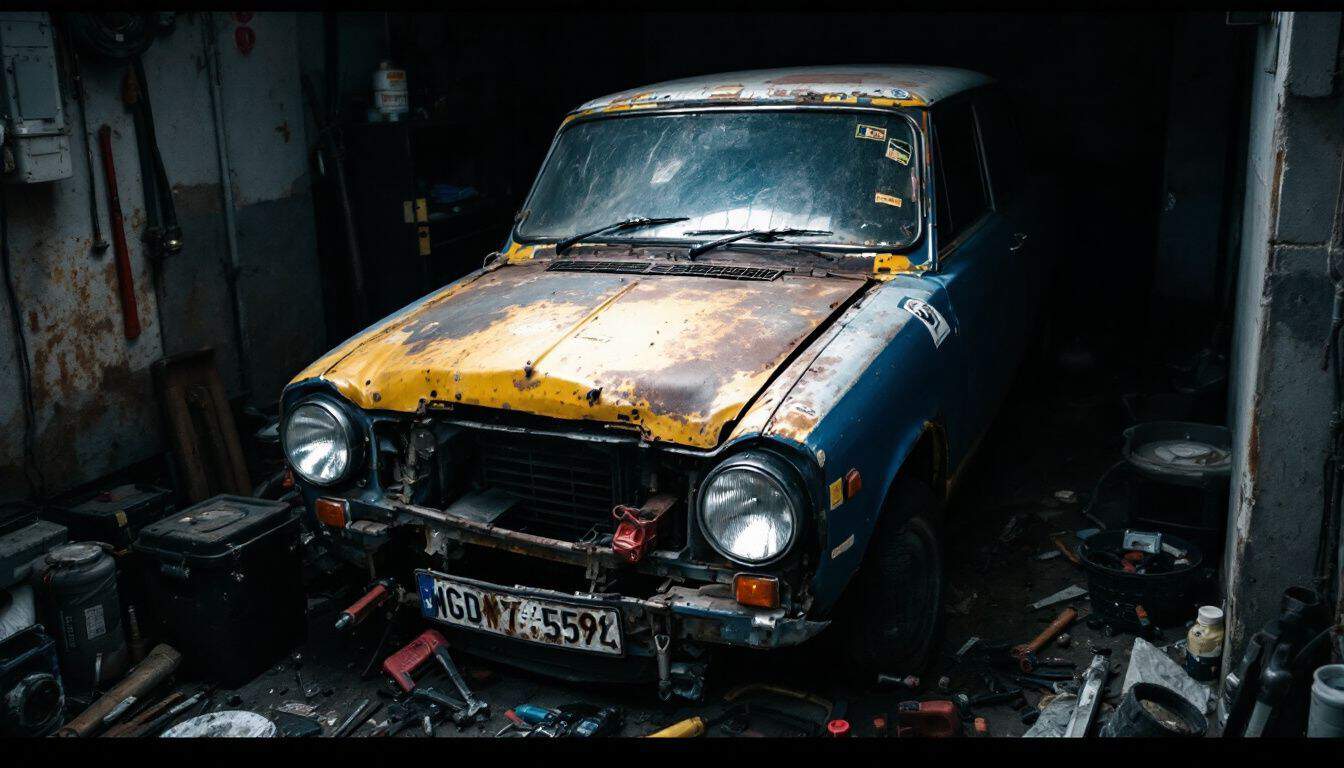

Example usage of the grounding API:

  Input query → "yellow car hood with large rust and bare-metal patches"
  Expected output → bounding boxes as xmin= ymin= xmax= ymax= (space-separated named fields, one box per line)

xmin=294 ymin=261 xmax=863 ymax=448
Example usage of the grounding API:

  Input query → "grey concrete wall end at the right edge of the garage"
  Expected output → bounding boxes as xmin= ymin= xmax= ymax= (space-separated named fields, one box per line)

xmin=1226 ymin=13 xmax=1344 ymax=663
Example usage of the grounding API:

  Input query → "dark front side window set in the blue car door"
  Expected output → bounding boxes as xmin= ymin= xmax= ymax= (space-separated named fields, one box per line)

xmin=933 ymin=100 xmax=989 ymax=243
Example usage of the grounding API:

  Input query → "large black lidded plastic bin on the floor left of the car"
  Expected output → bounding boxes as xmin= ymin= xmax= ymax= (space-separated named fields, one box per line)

xmin=134 ymin=495 xmax=306 ymax=687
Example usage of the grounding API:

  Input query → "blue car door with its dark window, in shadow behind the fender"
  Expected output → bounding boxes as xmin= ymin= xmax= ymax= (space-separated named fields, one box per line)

xmin=933 ymin=90 xmax=1036 ymax=463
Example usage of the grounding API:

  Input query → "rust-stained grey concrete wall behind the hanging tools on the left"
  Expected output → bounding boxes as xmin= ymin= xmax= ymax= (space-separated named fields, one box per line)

xmin=0 ymin=13 xmax=324 ymax=499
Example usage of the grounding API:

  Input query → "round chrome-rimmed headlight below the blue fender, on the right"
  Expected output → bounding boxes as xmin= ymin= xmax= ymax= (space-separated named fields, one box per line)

xmin=700 ymin=451 xmax=802 ymax=565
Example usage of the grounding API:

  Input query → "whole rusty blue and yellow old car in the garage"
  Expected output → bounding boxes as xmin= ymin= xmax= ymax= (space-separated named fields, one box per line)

xmin=281 ymin=65 xmax=1043 ymax=697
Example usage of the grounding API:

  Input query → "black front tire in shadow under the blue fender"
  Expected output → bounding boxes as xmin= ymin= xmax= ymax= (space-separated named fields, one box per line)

xmin=840 ymin=480 xmax=946 ymax=683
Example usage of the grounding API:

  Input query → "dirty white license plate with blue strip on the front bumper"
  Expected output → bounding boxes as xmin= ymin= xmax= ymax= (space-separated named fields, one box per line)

xmin=417 ymin=572 xmax=625 ymax=656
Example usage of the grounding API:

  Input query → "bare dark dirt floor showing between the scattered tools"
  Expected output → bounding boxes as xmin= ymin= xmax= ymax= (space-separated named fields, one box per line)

xmin=133 ymin=363 xmax=1220 ymax=737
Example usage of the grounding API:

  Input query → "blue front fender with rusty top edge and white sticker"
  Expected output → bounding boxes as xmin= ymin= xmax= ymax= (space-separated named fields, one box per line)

xmin=761 ymin=276 xmax=964 ymax=612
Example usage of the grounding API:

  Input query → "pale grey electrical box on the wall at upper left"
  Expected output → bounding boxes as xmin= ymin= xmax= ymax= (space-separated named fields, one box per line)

xmin=0 ymin=12 xmax=73 ymax=184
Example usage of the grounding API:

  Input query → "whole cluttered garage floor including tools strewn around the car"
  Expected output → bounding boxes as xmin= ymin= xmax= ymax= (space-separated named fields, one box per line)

xmin=2 ymin=355 xmax=1218 ymax=737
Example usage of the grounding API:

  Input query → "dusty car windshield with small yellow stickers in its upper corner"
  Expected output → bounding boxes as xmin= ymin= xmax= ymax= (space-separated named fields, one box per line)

xmin=516 ymin=110 xmax=919 ymax=249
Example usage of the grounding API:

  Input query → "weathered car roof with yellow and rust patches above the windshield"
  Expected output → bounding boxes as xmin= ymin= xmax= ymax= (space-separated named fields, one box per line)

xmin=571 ymin=65 xmax=993 ymax=116
